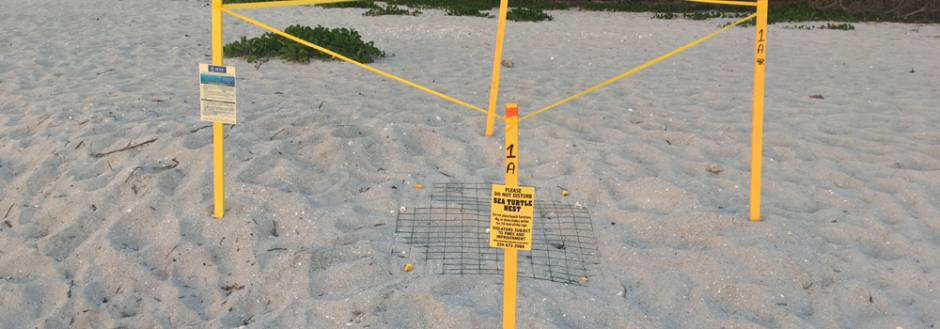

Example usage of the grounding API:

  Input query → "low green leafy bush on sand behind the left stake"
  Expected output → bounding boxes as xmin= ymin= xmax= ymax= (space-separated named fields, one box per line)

xmin=225 ymin=25 xmax=385 ymax=63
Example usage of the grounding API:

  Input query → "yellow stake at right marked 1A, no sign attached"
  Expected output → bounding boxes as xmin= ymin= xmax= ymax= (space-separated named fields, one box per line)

xmin=750 ymin=0 xmax=767 ymax=221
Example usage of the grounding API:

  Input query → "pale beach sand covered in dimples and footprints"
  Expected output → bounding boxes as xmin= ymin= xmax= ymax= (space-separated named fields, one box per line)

xmin=0 ymin=0 xmax=940 ymax=328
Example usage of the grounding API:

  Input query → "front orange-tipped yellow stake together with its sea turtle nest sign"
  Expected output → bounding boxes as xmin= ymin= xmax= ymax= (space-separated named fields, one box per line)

xmin=490 ymin=104 xmax=535 ymax=329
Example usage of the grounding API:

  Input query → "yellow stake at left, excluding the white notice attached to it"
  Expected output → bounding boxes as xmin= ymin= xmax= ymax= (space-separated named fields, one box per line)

xmin=212 ymin=0 xmax=225 ymax=219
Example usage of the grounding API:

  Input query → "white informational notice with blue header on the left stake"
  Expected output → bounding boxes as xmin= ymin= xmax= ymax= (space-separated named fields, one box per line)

xmin=199 ymin=64 xmax=235 ymax=125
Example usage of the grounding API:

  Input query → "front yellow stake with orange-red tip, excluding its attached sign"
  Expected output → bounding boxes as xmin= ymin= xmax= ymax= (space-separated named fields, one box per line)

xmin=503 ymin=103 xmax=519 ymax=329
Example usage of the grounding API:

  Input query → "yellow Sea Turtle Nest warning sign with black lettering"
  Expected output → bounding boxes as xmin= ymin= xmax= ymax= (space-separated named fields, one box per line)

xmin=490 ymin=184 xmax=535 ymax=250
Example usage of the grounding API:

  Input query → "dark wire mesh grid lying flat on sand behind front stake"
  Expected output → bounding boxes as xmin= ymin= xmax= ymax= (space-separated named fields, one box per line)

xmin=395 ymin=183 xmax=599 ymax=284
